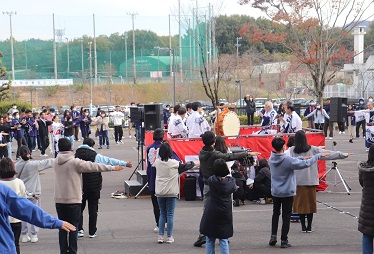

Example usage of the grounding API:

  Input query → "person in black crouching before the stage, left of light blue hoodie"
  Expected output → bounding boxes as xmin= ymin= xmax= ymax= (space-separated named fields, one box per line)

xmin=250 ymin=159 xmax=271 ymax=198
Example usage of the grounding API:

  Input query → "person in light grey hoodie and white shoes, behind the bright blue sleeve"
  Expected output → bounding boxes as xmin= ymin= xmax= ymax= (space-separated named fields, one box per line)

xmin=15 ymin=146 xmax=54 ymax=243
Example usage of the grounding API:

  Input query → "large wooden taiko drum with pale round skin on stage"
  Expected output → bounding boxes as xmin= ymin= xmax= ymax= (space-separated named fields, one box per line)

xmin=215 ymin=108 xmax=240 ymax=136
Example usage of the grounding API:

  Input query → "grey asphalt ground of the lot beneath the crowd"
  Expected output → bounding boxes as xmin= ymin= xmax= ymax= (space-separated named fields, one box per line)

xmin=16 ymin=131 xmax=367 ymax=254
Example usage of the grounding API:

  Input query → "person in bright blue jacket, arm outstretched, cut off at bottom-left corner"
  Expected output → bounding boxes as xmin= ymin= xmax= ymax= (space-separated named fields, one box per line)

xmin=0 ymin=184 xmax=76 ymax=254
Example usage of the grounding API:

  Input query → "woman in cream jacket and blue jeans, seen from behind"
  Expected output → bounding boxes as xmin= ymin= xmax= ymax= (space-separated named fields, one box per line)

xmin=153 ymin=142 xmax=195 ymax=243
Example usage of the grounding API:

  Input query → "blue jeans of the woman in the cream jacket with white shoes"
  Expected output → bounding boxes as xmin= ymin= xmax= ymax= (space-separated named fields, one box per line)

xmin=157 ymin=197 xmax=177 ymax=236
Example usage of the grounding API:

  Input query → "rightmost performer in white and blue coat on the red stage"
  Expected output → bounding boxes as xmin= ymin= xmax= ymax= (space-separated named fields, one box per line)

xmin=279 ymin=101 xmax=303 ymax=133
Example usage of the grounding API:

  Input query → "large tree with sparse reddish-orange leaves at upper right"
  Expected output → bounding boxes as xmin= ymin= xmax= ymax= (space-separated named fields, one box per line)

xmin=239 ymin=0 xmax=374 ymax=103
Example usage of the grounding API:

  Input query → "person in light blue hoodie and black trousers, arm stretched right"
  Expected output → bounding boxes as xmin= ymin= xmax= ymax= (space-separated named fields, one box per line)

xmin=269 ymin=137 xmax=329 ymax=248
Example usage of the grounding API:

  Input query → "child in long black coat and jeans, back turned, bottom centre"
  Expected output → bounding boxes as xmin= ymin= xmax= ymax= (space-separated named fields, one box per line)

xmin=200 ymin=159 xmax=237 ymax=254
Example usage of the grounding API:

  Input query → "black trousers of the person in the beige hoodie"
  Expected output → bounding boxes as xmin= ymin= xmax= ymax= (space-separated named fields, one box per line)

xmin=56 ymin=203 xmax=82 ymax=254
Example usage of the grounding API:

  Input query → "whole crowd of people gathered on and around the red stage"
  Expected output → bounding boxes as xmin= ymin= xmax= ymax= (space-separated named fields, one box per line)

xmin=0 ymin=96 xmax=374 ymax=254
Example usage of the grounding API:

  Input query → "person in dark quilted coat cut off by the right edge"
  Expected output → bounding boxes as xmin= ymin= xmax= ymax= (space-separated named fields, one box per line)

xmin=358 ymin=145 xmax=374 ymax=253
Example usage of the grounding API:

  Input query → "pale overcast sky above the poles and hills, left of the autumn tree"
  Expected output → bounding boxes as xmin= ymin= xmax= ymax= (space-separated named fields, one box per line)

xmin=0 ymin=0 xmax=258 ymax=40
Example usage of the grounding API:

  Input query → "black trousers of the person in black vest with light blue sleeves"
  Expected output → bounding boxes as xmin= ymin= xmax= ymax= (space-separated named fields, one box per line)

xmin=78 ymin=191 xmax=100 ymax=235
